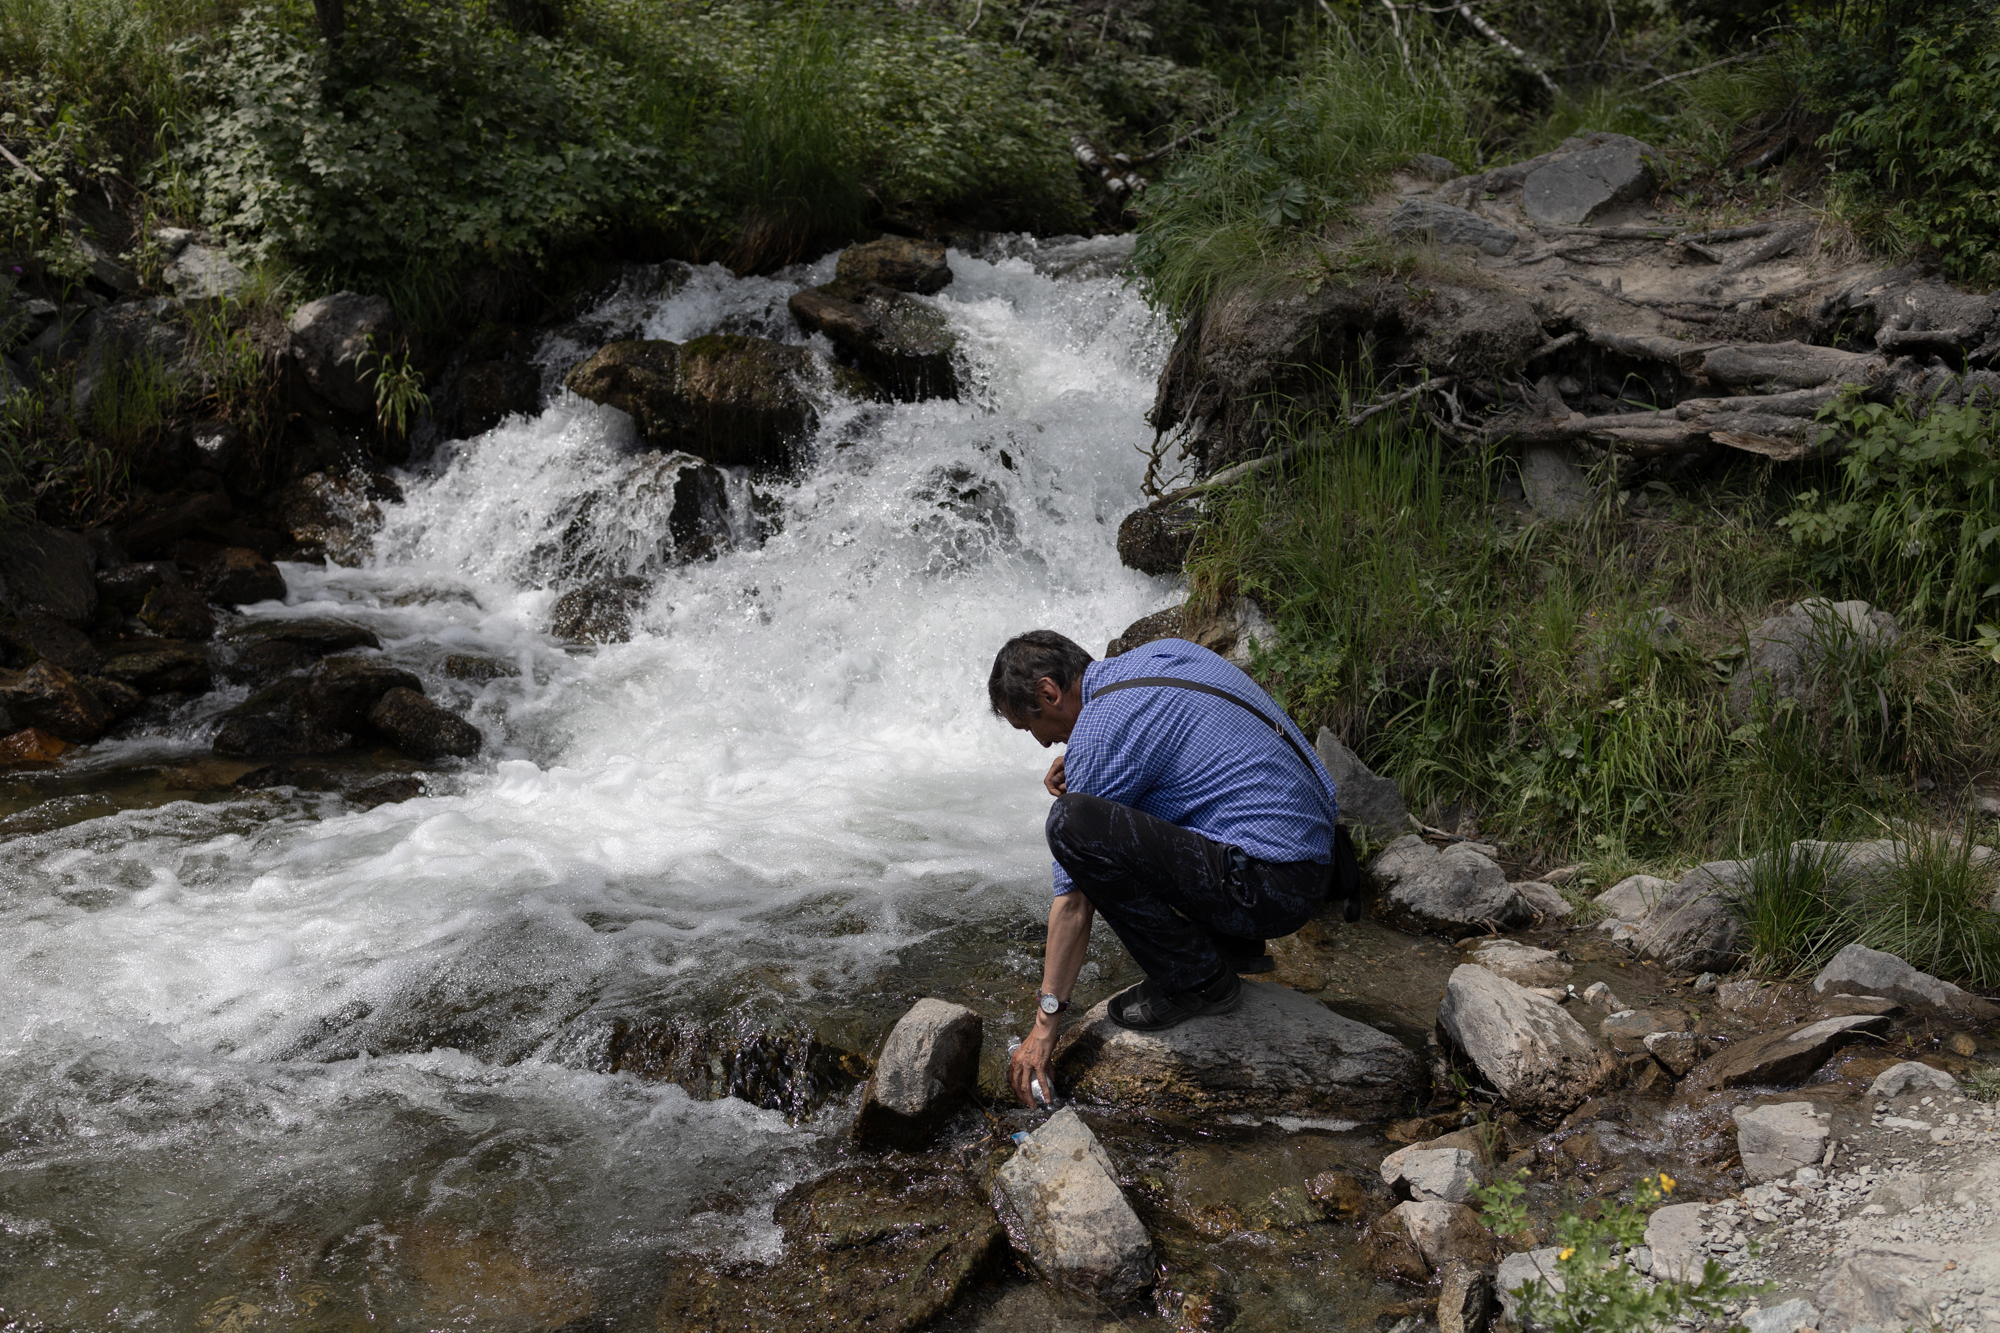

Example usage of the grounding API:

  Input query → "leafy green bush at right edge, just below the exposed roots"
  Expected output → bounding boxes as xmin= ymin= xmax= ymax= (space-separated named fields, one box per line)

xmin=1780 ymin=398 xmax=2000 ymax=638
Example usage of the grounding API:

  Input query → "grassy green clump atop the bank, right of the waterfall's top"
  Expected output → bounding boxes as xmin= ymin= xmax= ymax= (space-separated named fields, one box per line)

xmin=1134 ymin=28 xmax=1474 ymax=316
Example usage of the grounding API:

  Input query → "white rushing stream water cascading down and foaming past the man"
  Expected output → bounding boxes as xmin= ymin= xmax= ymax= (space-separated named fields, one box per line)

xmin=0 ymin=242 xmax=1170 ymax=1327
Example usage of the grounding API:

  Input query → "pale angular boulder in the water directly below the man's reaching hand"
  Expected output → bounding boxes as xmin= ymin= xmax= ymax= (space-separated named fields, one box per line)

xmin=992 ymin=1107 xmax=1154 ymax=1303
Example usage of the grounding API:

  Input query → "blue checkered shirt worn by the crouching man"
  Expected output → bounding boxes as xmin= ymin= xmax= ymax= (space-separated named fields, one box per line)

xmin=1056 ymin=638 xmax=1338 ymax=897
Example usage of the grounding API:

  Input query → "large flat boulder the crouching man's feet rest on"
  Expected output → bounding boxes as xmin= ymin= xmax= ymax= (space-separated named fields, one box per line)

xmin=1056 ymin=981 xmax=1422 ymax=1121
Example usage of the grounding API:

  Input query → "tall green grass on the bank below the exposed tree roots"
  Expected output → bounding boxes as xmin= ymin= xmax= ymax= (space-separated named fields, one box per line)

xmin=1188 ymin=420 xmax=2000 ymax=867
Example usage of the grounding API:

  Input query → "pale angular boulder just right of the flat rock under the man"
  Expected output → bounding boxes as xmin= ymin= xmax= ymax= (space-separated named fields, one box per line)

xmin=1438 ymin=963 xmax=1618 ymax=1117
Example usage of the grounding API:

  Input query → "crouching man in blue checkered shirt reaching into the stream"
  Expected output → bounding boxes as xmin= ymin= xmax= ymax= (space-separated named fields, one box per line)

xmin=986 ymin=630 xmax=1336 ymax=1105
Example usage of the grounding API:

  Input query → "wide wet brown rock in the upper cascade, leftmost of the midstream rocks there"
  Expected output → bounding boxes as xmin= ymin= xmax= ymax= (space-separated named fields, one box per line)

xmin=566 ymin=334 xmax=856 ymax=468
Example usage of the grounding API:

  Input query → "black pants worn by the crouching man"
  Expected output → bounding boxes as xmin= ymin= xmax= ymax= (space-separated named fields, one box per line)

xmin=1048 ymin=793 xmax=1330 ymax=991
